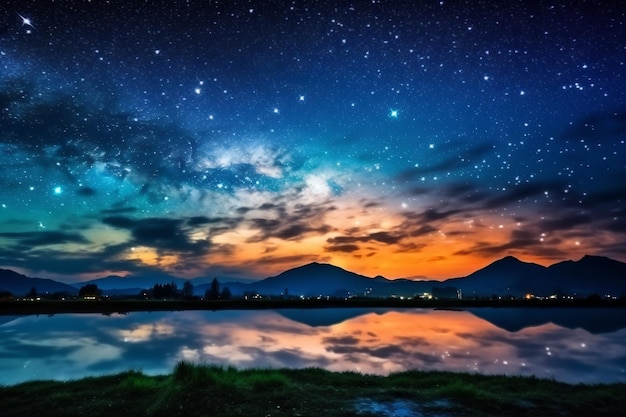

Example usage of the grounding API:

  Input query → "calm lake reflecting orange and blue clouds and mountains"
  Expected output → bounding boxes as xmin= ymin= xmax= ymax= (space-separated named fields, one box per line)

xmin=0 ymin=308 xmax=626 ymax=384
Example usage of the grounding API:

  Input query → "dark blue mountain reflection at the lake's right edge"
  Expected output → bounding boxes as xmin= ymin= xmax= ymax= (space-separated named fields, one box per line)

xmin=466 ymin=307 xmax=626 ymax=334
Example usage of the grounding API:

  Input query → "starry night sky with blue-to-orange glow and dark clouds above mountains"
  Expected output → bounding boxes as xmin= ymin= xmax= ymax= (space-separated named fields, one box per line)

xmin=0 ymin=0 xmax=626 ymax=282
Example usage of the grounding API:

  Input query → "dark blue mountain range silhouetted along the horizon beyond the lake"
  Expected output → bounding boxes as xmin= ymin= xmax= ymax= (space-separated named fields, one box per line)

xmin=0 ymin=255 xmax=626 ymax=298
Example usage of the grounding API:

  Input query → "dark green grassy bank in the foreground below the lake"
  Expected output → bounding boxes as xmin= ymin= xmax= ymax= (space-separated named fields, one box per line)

xmin=0 ymin=362 xmax=626 ymax=417
